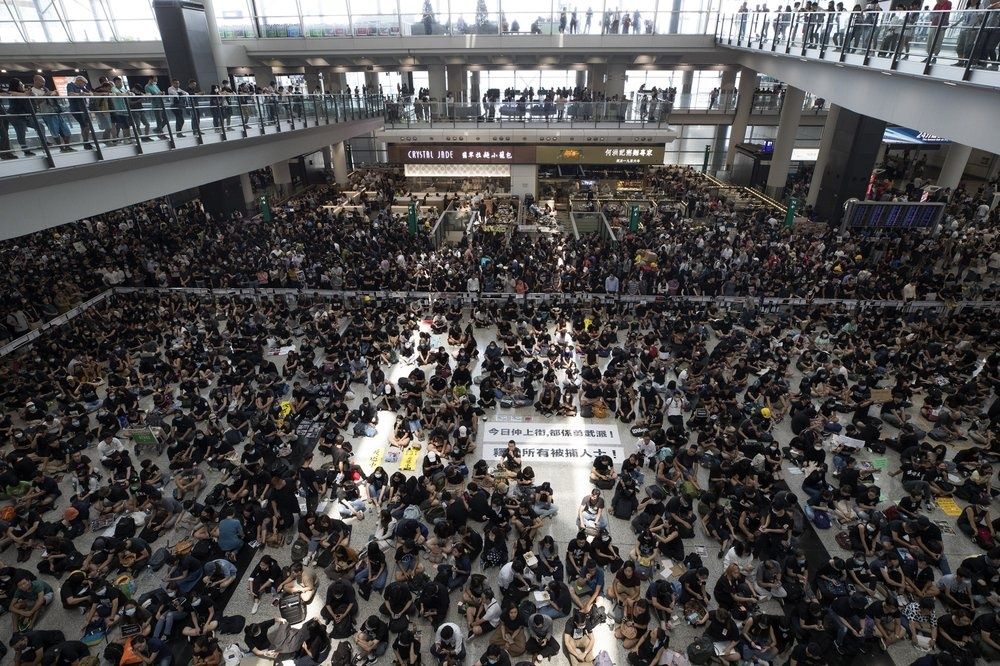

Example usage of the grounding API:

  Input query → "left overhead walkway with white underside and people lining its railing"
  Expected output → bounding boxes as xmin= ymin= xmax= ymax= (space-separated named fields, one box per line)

xmin=0 ymin=95 xmax=383 ymax=239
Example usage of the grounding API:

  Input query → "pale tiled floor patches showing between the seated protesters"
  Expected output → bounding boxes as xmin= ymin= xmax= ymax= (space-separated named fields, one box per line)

xmin=7 ymin=302 xmax=992 ymax=666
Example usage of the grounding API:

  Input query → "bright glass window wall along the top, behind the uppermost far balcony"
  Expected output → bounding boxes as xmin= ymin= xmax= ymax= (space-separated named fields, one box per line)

xmin=0 ymin=0 xmax=724 ymax=42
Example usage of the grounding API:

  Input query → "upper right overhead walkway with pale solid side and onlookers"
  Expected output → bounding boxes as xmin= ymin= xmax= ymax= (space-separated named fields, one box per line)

xmin=716 ymin=9 xmax=1000 ymax=153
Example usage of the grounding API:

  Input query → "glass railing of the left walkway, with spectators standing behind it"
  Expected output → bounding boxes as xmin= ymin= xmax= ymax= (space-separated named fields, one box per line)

xmin=0 ymin=94 xmax=385 ymax=171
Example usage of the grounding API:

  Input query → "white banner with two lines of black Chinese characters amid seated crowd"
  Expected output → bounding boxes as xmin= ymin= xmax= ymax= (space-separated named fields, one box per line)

xmin=482 ymin=420 xmax=624 ymax=465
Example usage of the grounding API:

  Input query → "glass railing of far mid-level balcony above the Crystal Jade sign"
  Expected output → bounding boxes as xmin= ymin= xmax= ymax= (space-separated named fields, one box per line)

xmin=385 ymin=90 xmax=826 ymax=129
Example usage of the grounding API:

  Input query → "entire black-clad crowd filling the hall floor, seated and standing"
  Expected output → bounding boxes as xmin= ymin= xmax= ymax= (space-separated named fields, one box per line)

xmin=0 ymin=163 xmax=1000 ymax=666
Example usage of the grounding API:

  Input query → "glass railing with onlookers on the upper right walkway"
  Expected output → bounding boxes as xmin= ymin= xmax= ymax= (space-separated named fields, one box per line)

xmin=716 ymin=9 xmax=1000 ymax=80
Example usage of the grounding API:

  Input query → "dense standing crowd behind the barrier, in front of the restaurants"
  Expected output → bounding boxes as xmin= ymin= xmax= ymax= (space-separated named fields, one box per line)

xmin=0 ymin=167 xmax=1000 ymax=344
